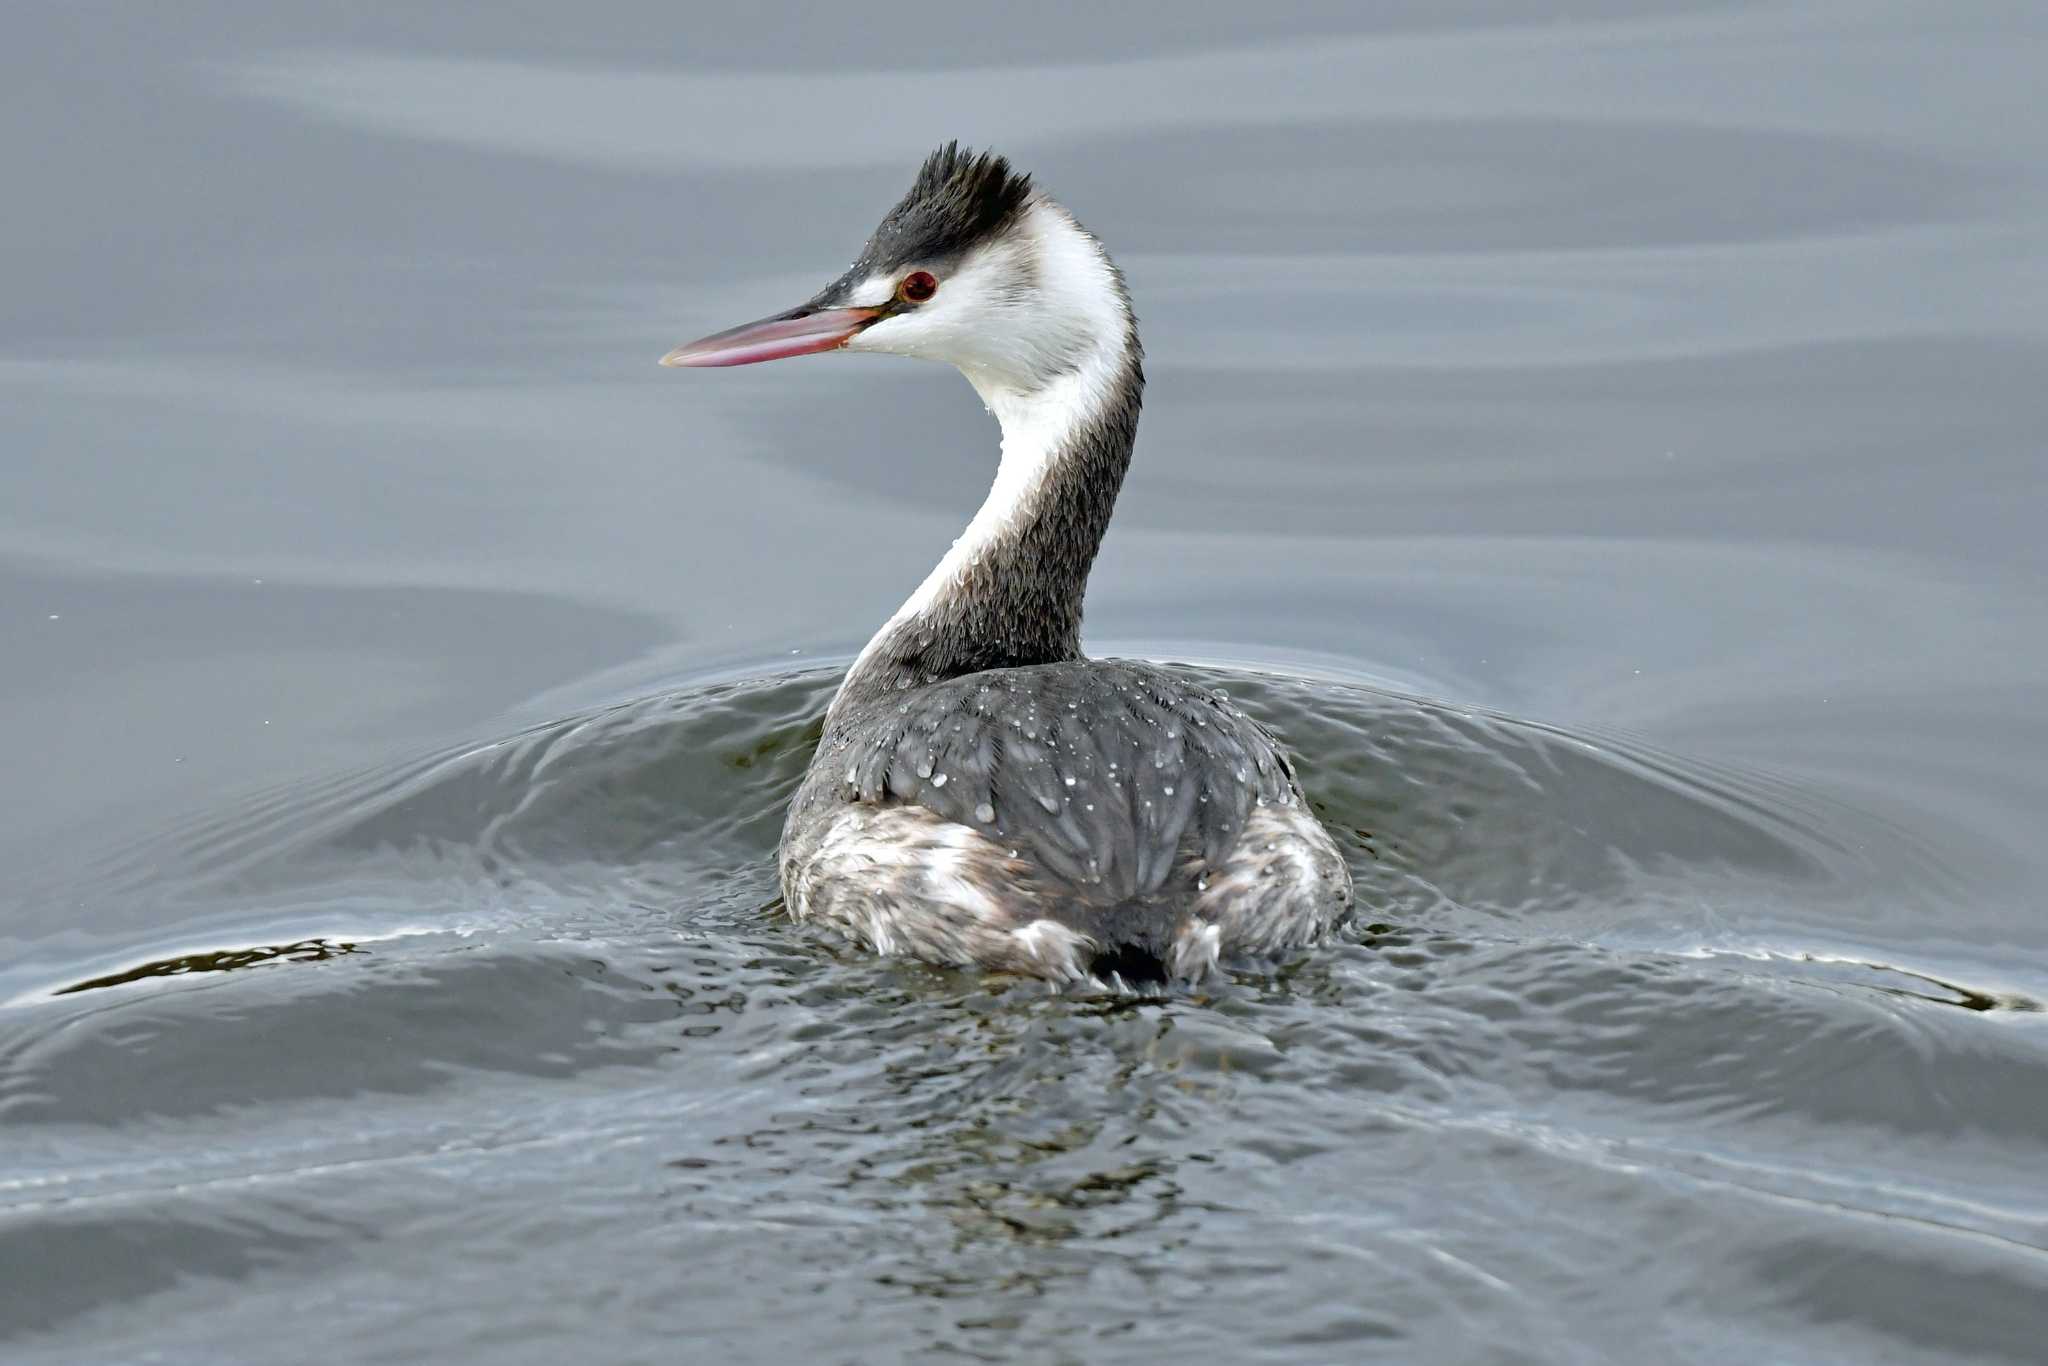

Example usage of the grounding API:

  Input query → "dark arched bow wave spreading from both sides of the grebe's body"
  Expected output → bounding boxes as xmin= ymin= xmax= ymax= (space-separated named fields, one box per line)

xmin=12 ymin=666 xmax=1862 ymax=989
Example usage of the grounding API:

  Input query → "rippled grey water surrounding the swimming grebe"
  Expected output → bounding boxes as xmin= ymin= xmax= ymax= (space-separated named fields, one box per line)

xmin=0 ymin=0 xmax=2048 ymax=1364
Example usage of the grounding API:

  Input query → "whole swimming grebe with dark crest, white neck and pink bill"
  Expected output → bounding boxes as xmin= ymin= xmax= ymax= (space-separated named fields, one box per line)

xmin=662 ymin=143 xmax=1352 ymax=983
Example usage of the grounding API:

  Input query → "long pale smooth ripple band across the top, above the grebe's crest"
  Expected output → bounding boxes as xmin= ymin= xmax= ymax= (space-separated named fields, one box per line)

xmin=213 ymin=8 xmax=2032 ymax=172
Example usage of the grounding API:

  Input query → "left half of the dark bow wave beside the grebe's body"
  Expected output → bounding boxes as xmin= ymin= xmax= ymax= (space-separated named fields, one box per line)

xmin=79 ymin=676 xmax=834 ymax=917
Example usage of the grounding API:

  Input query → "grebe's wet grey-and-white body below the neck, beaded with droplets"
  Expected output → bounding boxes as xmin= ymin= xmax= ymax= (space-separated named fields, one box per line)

xmin=782 ymin=659 xmax=1350 ymax=979
